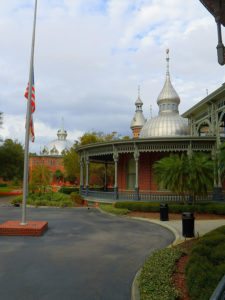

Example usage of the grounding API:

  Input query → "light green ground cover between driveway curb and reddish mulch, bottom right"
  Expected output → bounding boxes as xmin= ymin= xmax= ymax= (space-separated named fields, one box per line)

xmin=139 ymin=248 xmax=182 ymax=300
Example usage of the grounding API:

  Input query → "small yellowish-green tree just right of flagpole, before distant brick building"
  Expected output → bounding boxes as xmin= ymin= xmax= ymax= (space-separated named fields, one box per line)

xmin=30 ymin=165 xmax=51 ymax=194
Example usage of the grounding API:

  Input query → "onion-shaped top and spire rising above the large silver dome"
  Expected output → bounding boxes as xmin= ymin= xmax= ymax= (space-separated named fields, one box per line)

xmin=157 ymin=49 xmax=180 ymax=115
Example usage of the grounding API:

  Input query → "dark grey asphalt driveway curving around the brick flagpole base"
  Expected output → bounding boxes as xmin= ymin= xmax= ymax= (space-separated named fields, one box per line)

xmin=0 ymin=207 xmax=174 ymax=300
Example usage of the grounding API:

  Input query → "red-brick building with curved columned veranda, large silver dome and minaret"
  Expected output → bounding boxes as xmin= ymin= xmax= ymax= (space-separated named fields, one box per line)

xmin=77 ymin=50 xmax=225 ymax=201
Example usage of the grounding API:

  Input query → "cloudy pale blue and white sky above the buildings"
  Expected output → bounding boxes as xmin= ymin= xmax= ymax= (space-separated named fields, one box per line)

xmin=0 ymin=0 xmax=225 ymax=153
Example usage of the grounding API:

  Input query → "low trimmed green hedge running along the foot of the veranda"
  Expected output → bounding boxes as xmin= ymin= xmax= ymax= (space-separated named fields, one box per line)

xmin=115 ymin=201 xmax=225 ymax=215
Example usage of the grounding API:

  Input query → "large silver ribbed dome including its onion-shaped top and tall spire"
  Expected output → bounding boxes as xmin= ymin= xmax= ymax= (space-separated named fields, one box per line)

xmin=140 ymin=49 xmax=189 ymax=138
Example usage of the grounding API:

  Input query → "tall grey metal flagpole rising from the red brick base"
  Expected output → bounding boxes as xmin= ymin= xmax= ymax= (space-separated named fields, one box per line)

xmin=21 ymin=0 xmax=37 ymax=225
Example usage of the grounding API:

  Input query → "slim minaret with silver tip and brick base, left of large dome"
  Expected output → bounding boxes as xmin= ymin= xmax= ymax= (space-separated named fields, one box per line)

xmin=130 ymin=86 xmax=146 ymax=138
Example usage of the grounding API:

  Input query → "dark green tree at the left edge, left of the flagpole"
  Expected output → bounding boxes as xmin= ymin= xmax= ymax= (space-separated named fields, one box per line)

xmin=0 ymin=139 xmax=24 ymax=180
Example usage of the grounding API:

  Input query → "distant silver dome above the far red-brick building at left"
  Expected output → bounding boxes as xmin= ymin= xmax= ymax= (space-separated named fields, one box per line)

xmin=41 ymin=120 xmax=73 ymax=156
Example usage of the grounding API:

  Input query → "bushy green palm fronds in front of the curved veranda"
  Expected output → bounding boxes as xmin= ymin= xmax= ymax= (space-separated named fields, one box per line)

xmin=153 ymin=153 xmax=213 ymax=200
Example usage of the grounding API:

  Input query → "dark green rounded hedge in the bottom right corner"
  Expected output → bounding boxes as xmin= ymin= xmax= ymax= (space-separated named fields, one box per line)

xmin=186 ymin=226 xmax=225 ymax=300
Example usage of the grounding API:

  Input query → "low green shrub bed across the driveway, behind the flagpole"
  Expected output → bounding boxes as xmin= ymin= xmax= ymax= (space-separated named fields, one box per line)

xmin=11 ymin=193 xmax=73 ymax=207
